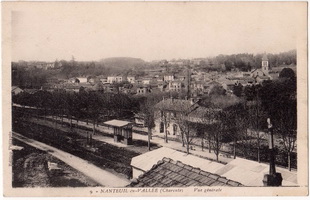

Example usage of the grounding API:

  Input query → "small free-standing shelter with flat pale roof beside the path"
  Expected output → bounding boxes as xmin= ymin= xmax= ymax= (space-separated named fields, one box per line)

xmin=104 ymin=119 xmax=133 ymax=145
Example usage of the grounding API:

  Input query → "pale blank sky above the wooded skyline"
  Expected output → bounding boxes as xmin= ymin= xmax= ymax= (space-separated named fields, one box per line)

xmin=12 ymin=2 xmax=301 ymax=61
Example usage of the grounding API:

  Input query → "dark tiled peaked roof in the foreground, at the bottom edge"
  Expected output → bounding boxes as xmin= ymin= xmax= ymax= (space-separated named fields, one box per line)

xmin=129 ymin=158 xmax=242 ymax=187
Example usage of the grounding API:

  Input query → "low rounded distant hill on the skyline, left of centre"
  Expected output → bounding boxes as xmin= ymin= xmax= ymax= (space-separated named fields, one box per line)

xmin=99 ymin=57 xmax=146 ymax=69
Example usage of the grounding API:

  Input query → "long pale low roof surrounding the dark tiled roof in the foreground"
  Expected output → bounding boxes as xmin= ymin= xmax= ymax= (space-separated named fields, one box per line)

xmin=131 ymin=147 xmax=298 ymax=186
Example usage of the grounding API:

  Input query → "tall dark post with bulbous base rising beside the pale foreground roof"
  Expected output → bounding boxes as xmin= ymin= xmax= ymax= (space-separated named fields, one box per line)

xmin=263 ymin=118 xmax=283 ymax=186
